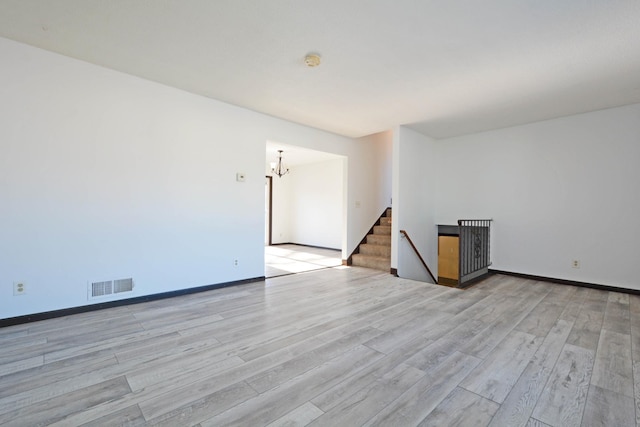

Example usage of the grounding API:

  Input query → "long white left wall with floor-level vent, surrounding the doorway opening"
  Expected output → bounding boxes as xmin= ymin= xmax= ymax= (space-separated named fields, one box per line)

xmin=0 ymin=39 xmax=385 ymax=318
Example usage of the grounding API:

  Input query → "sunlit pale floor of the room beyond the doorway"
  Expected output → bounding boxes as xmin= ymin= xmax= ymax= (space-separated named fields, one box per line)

xmin=264 ymin=245 xmax=342 ymax=278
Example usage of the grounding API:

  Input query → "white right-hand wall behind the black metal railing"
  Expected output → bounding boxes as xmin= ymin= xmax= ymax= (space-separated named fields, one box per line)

xmin=436 ymin=104 xmax=640 ymax=289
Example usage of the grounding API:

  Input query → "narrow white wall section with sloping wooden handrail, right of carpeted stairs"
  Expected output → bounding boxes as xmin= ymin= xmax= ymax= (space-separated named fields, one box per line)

xmin=391 ymin=126 xmax=438 ymax=283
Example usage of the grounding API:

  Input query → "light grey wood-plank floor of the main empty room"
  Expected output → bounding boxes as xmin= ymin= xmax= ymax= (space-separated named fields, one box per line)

xmin=0 ymin=267 xmax=640 ymax=427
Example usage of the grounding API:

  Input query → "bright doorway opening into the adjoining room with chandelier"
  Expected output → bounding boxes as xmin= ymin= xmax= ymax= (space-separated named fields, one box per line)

xmin=264 ymin=141 xmax=347 ymax=277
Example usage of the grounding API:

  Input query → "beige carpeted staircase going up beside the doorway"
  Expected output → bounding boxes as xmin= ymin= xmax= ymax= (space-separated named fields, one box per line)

xmin=352 ymin=208 xmax=391 ymax=273
